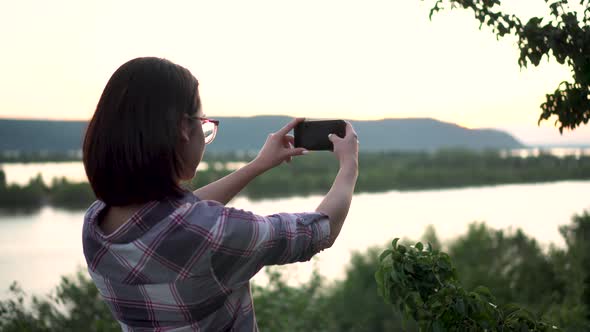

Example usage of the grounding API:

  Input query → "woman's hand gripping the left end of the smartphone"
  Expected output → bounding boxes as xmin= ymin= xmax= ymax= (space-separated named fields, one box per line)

xmin=252 ymin=118 xmax=307 ymax=171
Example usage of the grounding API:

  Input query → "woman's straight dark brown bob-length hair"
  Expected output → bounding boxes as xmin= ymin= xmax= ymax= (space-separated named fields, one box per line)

xmin=83 ymin=57 xmax=201 ymax=206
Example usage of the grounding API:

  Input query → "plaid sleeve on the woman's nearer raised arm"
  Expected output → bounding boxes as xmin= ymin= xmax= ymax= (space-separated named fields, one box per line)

xmin=206 ymin=202 xmax=330 ymax=287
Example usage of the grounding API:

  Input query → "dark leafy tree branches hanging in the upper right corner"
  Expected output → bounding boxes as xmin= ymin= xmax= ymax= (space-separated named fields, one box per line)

xmin=430 ymin=0 xmax=590 ymax=133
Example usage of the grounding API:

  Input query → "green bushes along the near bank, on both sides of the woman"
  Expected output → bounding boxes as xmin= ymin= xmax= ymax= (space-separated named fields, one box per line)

xmin=0 ymin=212 xmax=590 ymax=332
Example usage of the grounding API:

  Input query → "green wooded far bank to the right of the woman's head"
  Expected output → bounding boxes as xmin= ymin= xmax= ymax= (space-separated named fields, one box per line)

xmin=190 ymin=150 xmax=590 ymax=199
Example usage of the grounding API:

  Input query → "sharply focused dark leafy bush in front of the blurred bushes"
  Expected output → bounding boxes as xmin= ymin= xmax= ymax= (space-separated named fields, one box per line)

xmin=375 ymin=239 xmax=557 ymax=331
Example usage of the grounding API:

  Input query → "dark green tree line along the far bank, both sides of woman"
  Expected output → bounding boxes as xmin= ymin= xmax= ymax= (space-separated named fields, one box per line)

xmin=0 ymin=150 xmax=590 ymax=209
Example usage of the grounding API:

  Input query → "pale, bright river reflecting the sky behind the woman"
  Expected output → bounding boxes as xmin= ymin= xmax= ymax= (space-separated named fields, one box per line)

xmin=0 ymin=181 xmax=590 ymax=298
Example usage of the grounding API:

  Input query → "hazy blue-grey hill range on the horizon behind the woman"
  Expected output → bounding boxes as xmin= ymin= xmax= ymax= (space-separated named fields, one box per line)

xmin=0 ymin=116 xmax=523 ymax=152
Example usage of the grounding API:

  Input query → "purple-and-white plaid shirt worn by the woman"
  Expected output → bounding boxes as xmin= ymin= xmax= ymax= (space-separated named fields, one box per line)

xmin=83 ymin=192 xmax=330 ymax=331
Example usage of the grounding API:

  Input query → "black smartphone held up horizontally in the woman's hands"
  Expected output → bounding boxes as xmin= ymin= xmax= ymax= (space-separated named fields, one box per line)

xmin=294 ymin=120 xmax=346 ymax=151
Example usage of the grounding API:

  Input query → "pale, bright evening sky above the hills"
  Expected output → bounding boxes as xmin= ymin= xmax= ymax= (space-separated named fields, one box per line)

xmin=0 ymin=0 xmax=590 ymax=145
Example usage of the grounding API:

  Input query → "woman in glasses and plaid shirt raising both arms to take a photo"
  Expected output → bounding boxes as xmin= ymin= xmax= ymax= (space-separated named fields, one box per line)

xmin=83 ymin=58 xmax=358 ymax=331
